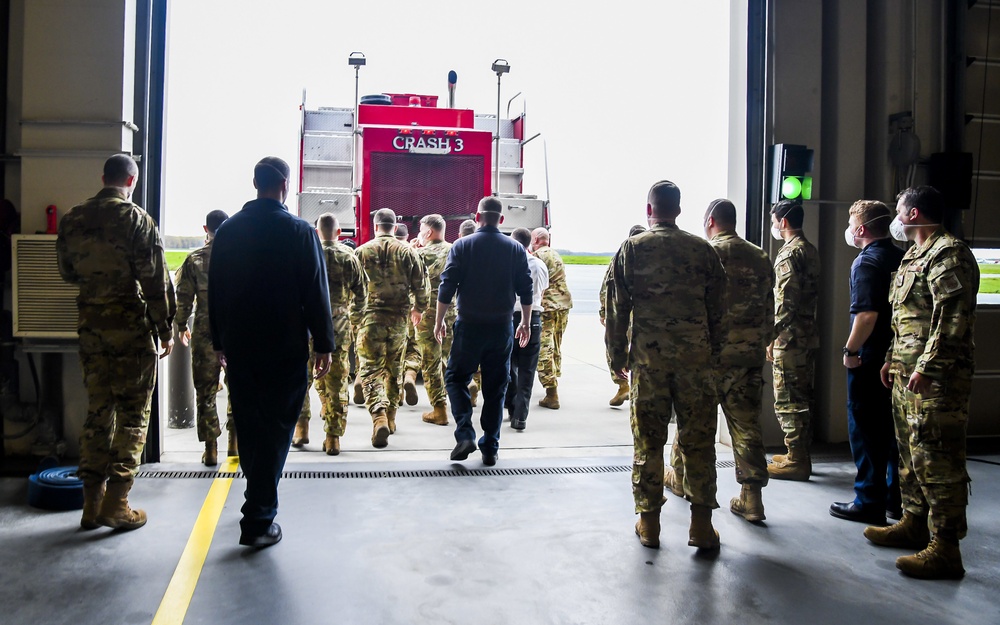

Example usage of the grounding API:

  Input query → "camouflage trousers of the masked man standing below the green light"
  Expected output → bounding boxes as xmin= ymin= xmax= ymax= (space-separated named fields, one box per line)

xmin=772 ymin=348 xmax=818 ymax=450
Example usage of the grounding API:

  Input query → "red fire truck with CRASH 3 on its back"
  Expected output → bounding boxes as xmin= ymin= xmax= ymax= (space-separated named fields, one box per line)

xmin=298 ymin=70 xmax=549 ymax=245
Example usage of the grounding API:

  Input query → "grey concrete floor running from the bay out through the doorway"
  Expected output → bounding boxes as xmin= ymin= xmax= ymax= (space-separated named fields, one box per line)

xmin=0 ymin=268 xmax=1000 ymax=625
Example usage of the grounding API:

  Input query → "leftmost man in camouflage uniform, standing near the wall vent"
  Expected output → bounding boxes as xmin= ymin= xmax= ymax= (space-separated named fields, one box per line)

xmin=56 ymin=154 xmax=176 ymax=529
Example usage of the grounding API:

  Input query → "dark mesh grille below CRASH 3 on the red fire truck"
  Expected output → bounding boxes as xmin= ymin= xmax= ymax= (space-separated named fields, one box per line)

xmin=369 ymin=152 xmax=483 ymax=223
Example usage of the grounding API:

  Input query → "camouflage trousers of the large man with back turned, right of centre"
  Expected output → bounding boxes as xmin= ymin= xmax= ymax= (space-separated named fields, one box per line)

xmin=629 ymin=364 xmax=719 ymax=512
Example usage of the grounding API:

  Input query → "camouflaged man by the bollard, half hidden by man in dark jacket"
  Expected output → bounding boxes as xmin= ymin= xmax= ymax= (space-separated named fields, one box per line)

xmin=174 ymin=210 xmax=237 ymax=467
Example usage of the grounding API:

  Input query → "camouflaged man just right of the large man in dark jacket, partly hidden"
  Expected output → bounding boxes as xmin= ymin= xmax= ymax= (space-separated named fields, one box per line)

xmin=316 ymin=213 xmax=368 ymax=456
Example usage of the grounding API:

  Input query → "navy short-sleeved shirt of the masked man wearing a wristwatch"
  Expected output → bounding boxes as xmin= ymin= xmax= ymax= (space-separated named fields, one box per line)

xmin=851 ymin=239 xmax=903 ymax=362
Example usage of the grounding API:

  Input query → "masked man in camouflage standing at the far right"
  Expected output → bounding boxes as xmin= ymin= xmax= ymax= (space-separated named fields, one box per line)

xmin=865 ymin=187 xmax=979 ymax=579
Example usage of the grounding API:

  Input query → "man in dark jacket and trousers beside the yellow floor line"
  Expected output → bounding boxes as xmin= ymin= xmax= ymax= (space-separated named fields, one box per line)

xmin=208 ymin=156 xmax=333 ymax=548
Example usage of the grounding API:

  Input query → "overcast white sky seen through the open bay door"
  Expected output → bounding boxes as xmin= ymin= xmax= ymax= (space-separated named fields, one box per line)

xmin=163 ymin=0 xmax=729 ymax=252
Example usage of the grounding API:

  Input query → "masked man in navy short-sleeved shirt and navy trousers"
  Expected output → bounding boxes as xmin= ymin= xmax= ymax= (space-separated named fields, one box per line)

xmin=830 ymin=200 xmax=903 ymax=525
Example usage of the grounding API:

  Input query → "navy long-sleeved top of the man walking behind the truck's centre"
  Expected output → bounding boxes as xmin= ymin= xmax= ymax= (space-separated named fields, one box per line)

xmin=438 ymin=226 xmax=532 ymax=325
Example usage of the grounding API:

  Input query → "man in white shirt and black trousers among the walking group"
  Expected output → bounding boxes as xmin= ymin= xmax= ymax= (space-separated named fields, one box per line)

xmin=504 ymin=228 xmax=549 ymax=430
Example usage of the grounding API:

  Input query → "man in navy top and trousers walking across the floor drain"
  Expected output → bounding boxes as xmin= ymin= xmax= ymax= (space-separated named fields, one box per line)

xmin=434 ymin=197 xmax=532 ymax=466
